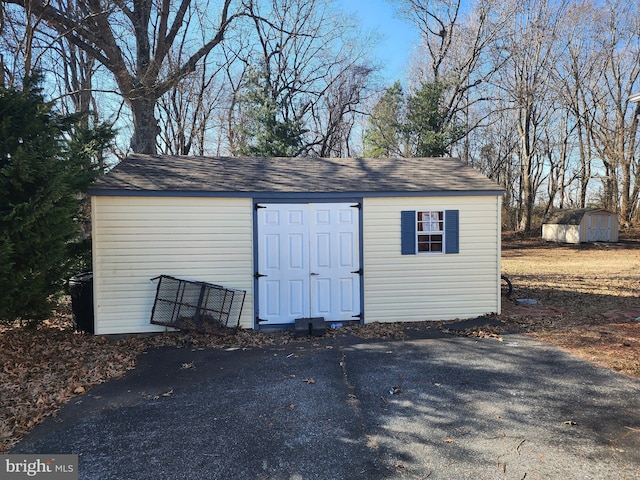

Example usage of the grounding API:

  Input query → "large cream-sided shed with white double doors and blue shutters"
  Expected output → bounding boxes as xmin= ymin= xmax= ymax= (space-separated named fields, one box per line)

xmin=89 ymin=154 xmax=502 ymax=334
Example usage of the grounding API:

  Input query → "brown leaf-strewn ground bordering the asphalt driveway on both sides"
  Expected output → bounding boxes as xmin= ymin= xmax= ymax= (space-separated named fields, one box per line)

xmin=0 ymin=229 xmax=640 ymax=453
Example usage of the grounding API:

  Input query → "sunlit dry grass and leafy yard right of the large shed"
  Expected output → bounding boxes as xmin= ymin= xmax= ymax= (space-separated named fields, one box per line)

xmin=502 ymin=231 xmax=640 ymax=378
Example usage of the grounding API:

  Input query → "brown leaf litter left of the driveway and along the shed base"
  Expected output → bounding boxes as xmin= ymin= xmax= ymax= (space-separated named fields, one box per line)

xmin=0 ymin=297 xmax=416 ymax=453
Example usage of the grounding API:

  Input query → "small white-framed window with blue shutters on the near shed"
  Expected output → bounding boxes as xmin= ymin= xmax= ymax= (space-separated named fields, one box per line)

xmin=400 ymin=210 xmax=460 ymax=255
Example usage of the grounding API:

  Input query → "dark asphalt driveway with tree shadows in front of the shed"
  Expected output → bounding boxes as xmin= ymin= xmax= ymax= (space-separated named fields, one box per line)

xmin=12 ymin=328 xmax=640 ymax=480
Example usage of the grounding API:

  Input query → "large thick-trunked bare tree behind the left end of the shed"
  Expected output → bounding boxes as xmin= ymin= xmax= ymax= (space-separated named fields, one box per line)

xmin=5 ymin=0 xmax=246 ymax=153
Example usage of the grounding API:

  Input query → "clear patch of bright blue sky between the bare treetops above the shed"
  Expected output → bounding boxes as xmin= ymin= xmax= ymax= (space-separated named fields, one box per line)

xmin=336 ymin=0 xmax=419 ymax=84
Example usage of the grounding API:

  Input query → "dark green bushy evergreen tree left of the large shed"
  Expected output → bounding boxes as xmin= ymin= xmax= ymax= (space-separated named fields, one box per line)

xmin=0 ymin=82 xmax=105 ymax=322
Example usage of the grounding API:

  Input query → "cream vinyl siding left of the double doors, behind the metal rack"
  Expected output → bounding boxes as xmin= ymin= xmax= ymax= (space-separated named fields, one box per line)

xmin=92 ymin=196 xmax=253 ymax=334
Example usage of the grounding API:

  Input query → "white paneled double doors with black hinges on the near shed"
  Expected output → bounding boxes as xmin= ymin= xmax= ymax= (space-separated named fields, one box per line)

xmin=257 ymin=203 xmax=360 ymax=325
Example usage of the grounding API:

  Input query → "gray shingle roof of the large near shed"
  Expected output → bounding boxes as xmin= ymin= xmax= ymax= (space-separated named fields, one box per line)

xmin=90 ymin=154 xmax=502 ymax=195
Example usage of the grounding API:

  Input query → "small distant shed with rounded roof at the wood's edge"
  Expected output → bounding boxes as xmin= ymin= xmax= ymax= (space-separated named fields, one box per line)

xmin=542 ymin=208 xmax=618 ymax=243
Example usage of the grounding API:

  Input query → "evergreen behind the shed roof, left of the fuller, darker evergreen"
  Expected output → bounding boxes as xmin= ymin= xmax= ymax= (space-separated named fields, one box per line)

xmin=364 ymin=82 xmax=406 ymax=158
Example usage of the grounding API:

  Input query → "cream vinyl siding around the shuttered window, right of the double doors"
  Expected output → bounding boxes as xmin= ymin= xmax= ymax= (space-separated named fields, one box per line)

xmin=362 ymin=196 xmax=501 ymax=323
